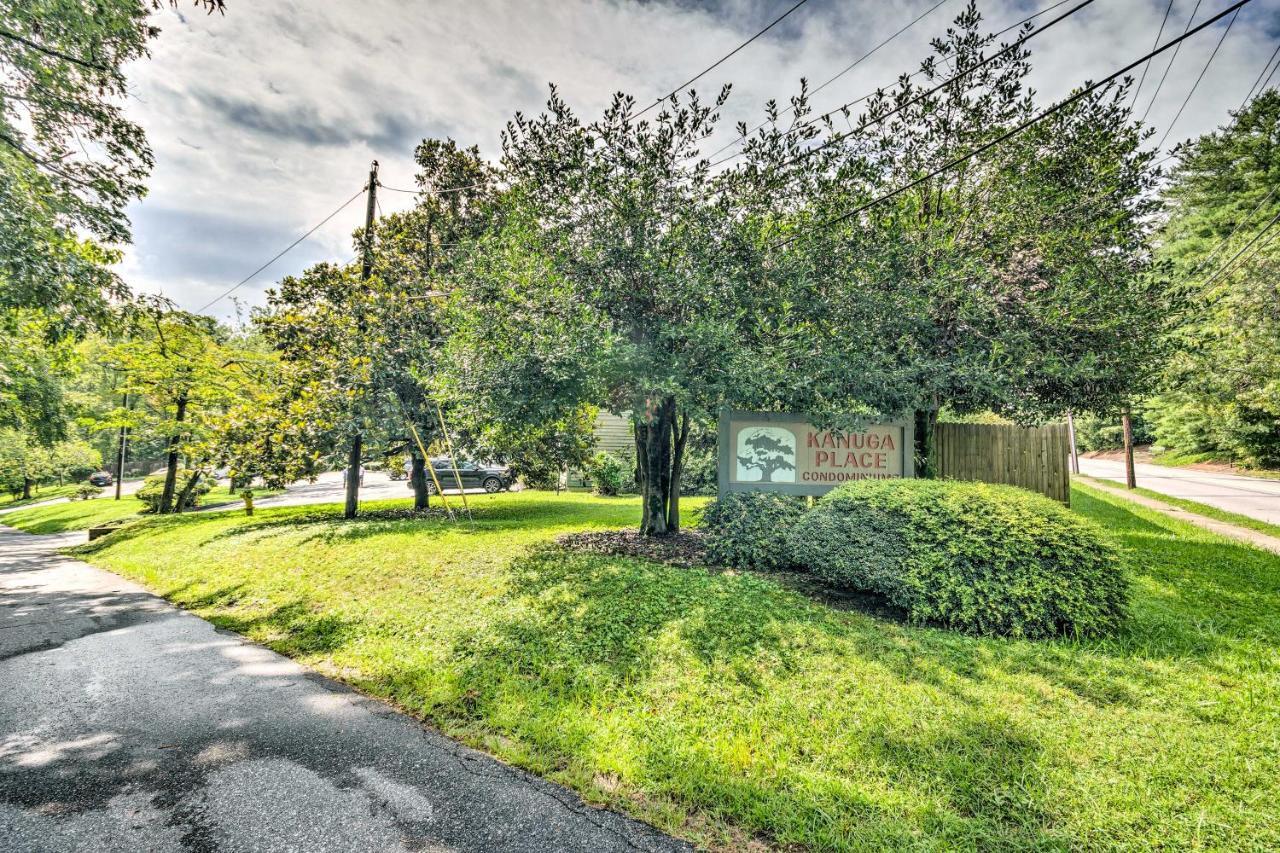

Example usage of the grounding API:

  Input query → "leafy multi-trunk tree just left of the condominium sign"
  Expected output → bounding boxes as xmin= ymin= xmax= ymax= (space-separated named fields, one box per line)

xmin=449 ymin=90 xmax=798 ymax=534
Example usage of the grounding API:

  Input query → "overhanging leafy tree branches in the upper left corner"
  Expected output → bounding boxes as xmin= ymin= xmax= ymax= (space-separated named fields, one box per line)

xmin=0 ymin=0 xmax=221 ymax=332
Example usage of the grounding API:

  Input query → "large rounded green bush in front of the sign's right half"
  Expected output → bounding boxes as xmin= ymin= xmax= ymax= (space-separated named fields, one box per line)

xmin=788 ymin=480 xmax=1128 ymax=637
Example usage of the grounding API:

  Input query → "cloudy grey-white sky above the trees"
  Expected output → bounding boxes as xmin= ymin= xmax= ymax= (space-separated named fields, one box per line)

xmin=120 ymin=0 xmax=1280 ymax=319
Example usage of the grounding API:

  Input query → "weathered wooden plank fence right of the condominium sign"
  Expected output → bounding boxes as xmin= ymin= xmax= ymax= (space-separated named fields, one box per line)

xmin=936 ymin=424 xmax=1071 ymax=505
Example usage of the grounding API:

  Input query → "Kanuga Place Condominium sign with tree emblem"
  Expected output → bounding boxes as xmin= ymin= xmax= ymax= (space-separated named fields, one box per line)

xmin=719 ymin=411 xmax=915 ymax=494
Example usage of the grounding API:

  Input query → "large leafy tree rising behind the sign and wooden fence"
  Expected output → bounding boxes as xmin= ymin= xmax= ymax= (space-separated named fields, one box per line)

xmin=748 ymin=4 xmax=1170 ymax=475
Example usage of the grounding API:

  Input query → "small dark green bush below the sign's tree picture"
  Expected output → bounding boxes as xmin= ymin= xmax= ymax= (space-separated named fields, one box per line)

xmin=701 ymin=492 xmax=805 ymax=570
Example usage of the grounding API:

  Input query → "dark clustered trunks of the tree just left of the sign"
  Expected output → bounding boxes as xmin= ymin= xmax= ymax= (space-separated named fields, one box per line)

xmin=635 ymin=397 xmax=689 ymax=537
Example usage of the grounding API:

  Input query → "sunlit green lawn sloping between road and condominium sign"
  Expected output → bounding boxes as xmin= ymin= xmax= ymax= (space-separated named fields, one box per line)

xmin=72 ymin=488 xmax=1280 ymax=849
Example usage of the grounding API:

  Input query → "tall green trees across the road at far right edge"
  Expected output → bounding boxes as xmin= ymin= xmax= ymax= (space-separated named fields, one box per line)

xmin=1147 ymin=88 xmax=1280 ymax=467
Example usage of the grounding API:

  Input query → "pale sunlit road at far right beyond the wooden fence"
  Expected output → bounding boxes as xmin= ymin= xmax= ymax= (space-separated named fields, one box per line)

xmin=1080 ymin=457 xmax=1280 ymax=524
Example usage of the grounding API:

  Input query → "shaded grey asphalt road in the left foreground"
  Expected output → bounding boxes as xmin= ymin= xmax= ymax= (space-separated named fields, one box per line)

xmin=0 ymin=526 xmax=690 ymax=853
